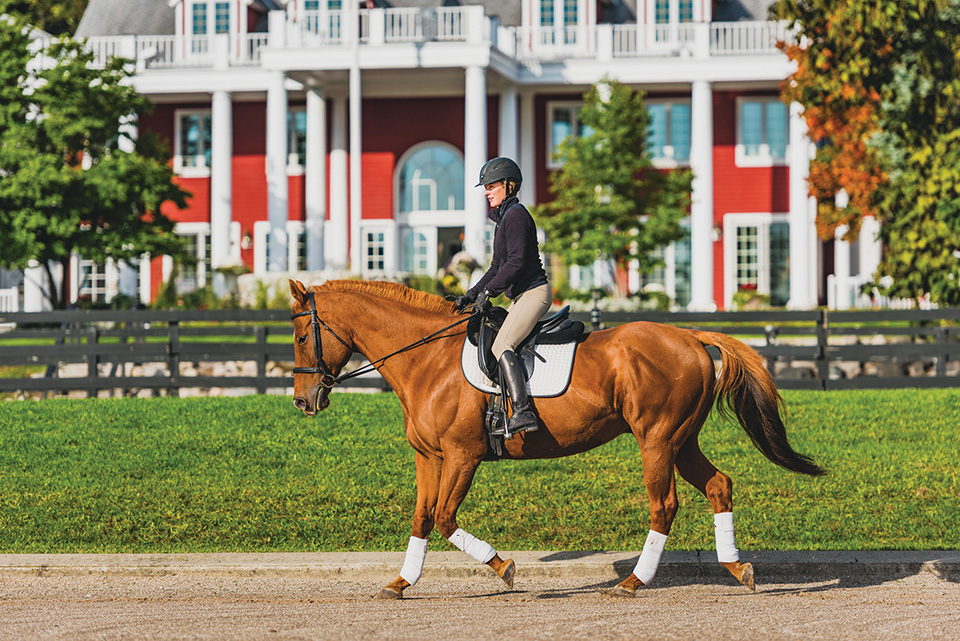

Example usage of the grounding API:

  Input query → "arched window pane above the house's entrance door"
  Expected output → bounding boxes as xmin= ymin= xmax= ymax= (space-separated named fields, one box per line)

xmin=399 ymin=143 xmax=463 ymax=213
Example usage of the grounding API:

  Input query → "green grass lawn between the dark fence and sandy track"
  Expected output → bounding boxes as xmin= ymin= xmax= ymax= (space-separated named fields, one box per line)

xmin=0 ymin=390 xmax=960 ymax=553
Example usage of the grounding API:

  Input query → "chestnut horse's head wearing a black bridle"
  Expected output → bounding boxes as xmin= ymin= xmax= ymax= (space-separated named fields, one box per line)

xmin=290 ymin=280 xmax=353 ymax=416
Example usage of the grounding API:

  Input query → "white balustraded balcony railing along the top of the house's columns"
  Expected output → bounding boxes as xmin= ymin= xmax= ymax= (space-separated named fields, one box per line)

xmin=80 ymin=6 xmax=791 ymax=70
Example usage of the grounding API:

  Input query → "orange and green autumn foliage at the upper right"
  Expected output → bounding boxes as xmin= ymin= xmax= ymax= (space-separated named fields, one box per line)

xmin=773 ymin=0 xmax=960 ymax=304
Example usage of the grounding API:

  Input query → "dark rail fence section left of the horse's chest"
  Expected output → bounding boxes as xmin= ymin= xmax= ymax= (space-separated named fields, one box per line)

xmin=0 ymin=310 xmax=389 ymax=396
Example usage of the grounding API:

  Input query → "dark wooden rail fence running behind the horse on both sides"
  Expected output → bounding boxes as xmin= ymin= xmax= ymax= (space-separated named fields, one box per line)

xmin=0 ymin=309 xmax=960 ymax=396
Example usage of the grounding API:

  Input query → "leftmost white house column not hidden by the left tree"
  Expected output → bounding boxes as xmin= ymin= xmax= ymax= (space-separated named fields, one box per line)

xmin=210 ymin=91 xmax=233 ymax=296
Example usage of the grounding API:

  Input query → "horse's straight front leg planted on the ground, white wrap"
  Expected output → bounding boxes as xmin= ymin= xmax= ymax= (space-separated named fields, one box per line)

xmin=379 ymin=452 xmax=443 ymax=599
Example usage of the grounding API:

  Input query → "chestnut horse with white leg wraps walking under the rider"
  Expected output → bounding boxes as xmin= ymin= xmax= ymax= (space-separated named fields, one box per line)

xmin=289 ymin=280 xmax=825 ymax=599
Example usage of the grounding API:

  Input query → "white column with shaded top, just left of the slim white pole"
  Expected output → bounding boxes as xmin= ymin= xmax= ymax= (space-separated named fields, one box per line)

xmin=324 ymin=95 xmax=350 ymax=270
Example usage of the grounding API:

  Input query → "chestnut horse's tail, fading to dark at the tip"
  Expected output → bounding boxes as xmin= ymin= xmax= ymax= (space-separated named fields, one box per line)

xmin=695 ymin=332 xmax=826 ymax=476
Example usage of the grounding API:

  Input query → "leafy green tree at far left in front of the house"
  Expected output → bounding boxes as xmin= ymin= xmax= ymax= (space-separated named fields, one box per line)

xmin=0 ymin=9 xmax=189 ymax=308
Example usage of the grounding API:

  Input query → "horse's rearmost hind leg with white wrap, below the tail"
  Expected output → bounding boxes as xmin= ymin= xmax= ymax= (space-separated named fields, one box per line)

xmin=677 ymin=438 xmax=756 ymax=590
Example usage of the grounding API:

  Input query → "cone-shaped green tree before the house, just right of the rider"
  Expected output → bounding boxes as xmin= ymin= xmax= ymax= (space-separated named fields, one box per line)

xmin=534 ymin=79 xmax=692 ymax=298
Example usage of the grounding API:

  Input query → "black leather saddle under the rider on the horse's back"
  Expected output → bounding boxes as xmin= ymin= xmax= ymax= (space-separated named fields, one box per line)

xmin=467 ymin=305 xmax=585 ymax=381
